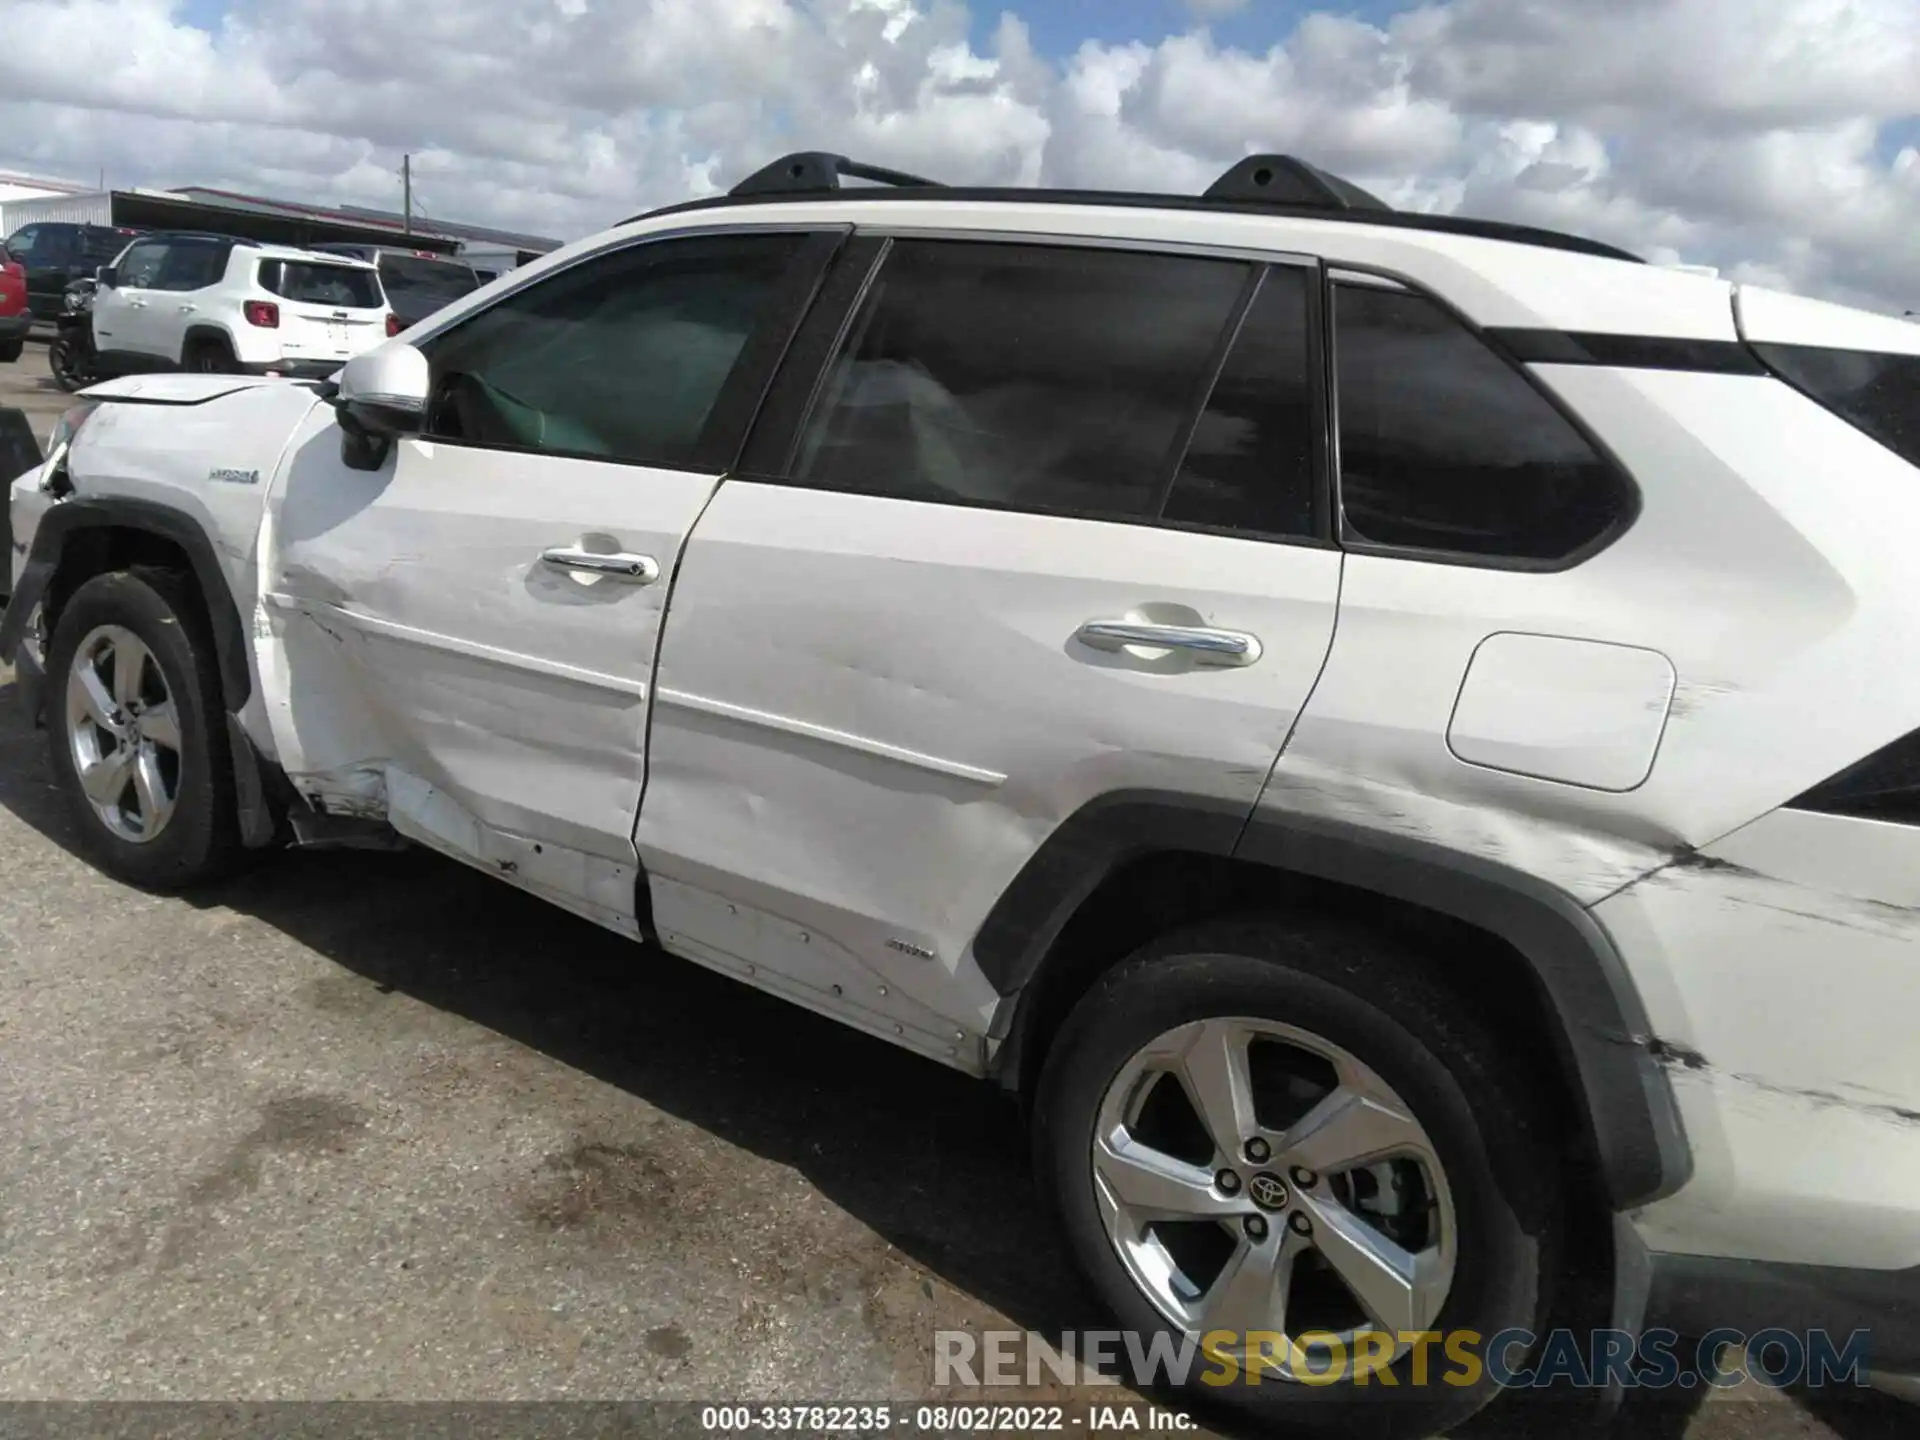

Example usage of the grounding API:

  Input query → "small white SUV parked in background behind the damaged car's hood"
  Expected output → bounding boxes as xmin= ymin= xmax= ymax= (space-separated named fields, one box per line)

xmin=92 ymin=234 xmax=399 ymax=376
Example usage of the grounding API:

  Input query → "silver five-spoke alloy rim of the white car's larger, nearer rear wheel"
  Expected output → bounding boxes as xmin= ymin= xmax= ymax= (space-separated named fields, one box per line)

xmin=1092 ymin=1018 xmax=1457 ymax=1379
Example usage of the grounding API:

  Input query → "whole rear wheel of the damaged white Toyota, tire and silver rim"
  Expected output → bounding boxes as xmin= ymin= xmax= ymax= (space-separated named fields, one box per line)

xmin=1035 ymin=922 xmax=1559 ymax=1436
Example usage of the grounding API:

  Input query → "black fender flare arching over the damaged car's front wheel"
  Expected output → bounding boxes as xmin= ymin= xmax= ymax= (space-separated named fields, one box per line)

xmin=0 ymin=495 xmax=253 ymax=714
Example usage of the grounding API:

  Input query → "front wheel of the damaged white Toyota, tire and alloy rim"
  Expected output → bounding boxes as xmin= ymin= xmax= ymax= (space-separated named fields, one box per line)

xmin=46 ymin=568 xmax=240 ymax=891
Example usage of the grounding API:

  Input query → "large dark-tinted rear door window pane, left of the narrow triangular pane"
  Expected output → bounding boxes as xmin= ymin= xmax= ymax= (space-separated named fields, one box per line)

xmin=795 ymin=240 xmax=1248 ymax=518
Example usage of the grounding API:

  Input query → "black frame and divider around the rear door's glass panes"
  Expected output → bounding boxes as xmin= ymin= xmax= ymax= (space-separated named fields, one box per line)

xmin=733 ymin=223 xmax=1340 ymax=549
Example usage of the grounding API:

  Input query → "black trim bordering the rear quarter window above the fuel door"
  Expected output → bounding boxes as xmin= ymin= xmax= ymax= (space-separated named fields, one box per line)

xmin=1321 ymin=257 xmax=1644 ymax=574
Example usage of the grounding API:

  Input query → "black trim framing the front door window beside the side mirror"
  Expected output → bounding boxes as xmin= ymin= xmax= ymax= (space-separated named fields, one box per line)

xmin=401 ymin=221 xmax=852 ymax=476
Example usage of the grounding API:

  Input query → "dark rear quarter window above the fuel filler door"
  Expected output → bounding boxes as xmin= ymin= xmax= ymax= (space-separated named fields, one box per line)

xmin=1334 ymin=286 xmax=1632 ymax=561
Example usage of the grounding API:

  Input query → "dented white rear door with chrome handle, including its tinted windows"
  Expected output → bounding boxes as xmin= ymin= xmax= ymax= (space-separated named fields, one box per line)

xmin=636 ymin=236 xmax=1340 ymax=1064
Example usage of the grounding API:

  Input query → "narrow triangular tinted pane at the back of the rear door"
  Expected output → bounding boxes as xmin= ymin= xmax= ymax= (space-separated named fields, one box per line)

xmin=1164 ymin=267 xmax=1321 ymax=536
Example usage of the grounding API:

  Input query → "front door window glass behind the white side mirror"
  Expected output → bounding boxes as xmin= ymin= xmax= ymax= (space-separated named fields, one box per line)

xmin=426 ymin=234 xmax=804 ymax=468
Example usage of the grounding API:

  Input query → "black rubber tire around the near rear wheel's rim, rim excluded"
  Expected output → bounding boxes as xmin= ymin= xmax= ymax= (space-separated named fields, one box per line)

xmin=1033 ymin=920 xmax=1561 ymax=1436
